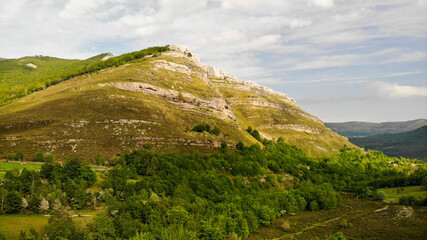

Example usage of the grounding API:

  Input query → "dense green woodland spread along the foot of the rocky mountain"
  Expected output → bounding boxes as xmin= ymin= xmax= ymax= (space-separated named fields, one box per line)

xmin=0 ymin=139 xmax=427 ymax=239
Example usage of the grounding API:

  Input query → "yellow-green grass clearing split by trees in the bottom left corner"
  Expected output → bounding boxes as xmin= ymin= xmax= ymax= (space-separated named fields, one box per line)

xmin=0 ymin=210 xmax=101 ymax=239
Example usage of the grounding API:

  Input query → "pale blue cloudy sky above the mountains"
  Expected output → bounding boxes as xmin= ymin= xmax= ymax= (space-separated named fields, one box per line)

xmin=0 ymin=0 xmax=427 ymax=122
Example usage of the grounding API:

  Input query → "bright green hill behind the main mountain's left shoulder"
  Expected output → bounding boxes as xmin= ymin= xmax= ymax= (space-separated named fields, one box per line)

xmin=0 ymin=53 xmax=109 ymax=106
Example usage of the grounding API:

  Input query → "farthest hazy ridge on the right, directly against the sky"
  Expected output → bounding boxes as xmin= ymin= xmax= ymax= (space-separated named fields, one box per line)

xmin=325 ymin=119 xmax=427 ymax=137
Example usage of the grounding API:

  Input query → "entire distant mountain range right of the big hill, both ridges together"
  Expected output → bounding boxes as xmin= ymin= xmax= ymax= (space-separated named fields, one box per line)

xmin=325 ymin=119 xmax=427 ymax=159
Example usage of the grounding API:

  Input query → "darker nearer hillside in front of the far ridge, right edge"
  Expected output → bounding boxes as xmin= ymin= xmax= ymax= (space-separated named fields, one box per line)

xmin=349 ymin=126 xmax=427 ymax=159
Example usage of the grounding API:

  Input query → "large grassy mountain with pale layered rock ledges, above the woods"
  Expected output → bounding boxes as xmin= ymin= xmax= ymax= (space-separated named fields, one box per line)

xmin=0 ymin=45 xmax=353 ymax=159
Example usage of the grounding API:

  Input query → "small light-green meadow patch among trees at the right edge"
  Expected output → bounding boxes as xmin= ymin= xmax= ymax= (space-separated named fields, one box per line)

xmin=379 ymin=186 xmax=427 ymax=203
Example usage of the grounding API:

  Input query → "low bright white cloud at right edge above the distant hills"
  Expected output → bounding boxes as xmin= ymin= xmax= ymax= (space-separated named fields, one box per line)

xmin=365 ymin=81 xmax=427 ymax=99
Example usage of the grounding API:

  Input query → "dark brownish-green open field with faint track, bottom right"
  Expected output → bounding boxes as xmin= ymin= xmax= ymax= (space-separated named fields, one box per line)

xmin=247 ymin=195 xmax=427 ymax=240
